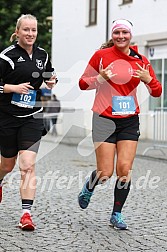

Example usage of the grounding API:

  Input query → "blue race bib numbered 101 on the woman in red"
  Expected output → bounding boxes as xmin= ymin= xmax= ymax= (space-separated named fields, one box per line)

xmin=112 ymin=96 xmax=136 ymax=115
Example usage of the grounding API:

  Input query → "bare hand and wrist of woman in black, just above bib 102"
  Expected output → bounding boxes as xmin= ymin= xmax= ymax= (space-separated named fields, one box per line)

xmin=4 ymin=82 xmax=34 ymax=94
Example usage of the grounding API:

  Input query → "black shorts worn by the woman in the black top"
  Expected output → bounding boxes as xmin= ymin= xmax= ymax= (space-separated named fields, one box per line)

xmin=0 ymin=112 xmax=44 ymax=158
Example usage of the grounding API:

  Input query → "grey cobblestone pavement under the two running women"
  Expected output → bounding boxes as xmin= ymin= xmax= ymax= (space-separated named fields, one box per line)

xmin=0 ymin=141 xmax=167 ymax=252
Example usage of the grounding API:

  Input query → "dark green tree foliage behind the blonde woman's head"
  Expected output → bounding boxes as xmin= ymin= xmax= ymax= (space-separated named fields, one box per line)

xmin=0 ymin=0 xmax=52 ymax=56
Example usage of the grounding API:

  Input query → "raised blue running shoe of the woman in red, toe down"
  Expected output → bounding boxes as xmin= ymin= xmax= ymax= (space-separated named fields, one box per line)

xmin=78 ymin=180 xmax=93 ymax=209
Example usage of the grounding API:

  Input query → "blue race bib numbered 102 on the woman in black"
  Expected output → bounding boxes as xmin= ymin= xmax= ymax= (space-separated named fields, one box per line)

xmin=11 ymin=89 xmax=36 ymax=108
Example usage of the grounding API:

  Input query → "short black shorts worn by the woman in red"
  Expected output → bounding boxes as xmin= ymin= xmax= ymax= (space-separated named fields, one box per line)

xmin=92 ymin=113 xmax=140 ymax=143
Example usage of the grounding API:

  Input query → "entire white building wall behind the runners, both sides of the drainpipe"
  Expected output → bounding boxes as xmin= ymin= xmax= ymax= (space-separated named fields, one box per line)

xmin=52 ymin=0 xmax=167 ymax=139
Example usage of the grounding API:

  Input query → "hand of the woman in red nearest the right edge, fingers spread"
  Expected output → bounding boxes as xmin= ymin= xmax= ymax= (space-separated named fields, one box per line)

xmin=133 ymin=62 xmax=152 ymax=84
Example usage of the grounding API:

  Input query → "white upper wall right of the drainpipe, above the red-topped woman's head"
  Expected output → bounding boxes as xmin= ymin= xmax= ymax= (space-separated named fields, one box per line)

xmin=110 ymin=0 xmax=167 ymax=36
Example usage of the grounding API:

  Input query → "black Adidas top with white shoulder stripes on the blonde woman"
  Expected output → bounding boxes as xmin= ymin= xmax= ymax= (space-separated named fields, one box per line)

xmin=0 ymin=43 xmax=54 ymax=116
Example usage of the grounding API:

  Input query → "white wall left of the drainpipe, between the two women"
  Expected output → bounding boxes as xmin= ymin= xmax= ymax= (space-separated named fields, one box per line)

xmin=52 ymin=0 xmax=106 ymax=109
